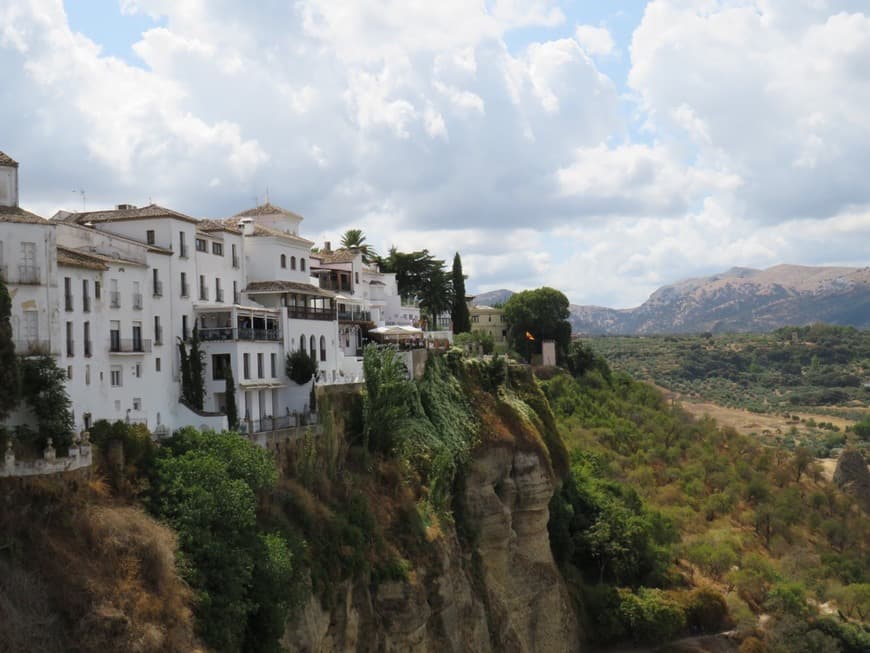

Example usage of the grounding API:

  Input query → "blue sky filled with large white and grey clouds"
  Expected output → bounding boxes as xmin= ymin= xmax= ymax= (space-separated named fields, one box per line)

xmin=0 ymin=0 xmax=870 ymax=308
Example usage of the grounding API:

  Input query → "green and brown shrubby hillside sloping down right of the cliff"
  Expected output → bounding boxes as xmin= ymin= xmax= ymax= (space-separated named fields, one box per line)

xmin=543 ymin=343 xmax=870 ymax=651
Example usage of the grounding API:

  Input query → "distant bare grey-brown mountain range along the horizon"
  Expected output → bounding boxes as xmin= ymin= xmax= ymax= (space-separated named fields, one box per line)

xmin=474 ymin=265 xmax=870 ymax=335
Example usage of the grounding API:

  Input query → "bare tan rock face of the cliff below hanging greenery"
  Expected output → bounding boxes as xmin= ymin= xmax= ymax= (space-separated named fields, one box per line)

xmin=283 ymin=444 xmax=579 ymax=653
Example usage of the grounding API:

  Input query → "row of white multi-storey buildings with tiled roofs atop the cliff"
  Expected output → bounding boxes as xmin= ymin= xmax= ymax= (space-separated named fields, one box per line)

xmin=0 ymin=153 xmax=419 ymax=432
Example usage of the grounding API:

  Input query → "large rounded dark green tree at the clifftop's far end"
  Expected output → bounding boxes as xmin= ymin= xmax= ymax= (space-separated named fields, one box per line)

xmin=504 ymin=287 xmax=571 ymax=360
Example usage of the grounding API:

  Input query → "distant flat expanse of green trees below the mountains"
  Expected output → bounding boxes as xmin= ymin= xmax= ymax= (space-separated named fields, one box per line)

xmin=590 ymin=324 xmax=870 ymax=414
